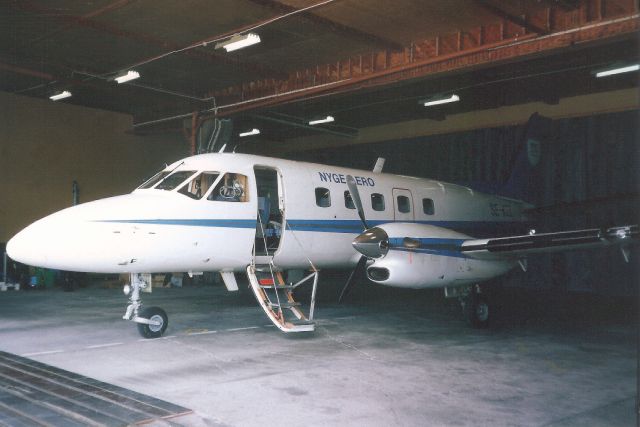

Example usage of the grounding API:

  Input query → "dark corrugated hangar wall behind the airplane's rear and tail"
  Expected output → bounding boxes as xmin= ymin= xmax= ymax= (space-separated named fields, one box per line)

xmin=291 ymin=109 xmax=640 ymax=296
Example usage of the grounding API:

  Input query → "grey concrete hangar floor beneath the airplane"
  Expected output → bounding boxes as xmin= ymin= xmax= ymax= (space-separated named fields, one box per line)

xmin=0 ymin=278 xmax=637 ymax=426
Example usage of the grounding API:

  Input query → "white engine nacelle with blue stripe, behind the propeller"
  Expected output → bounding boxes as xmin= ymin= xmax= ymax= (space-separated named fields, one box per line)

xmin=366 ymin=223 xmax=515 ymax=288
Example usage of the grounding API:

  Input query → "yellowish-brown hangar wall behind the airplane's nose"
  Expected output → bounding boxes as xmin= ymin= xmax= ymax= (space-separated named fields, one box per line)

xmin=0 ymin=92 xmax=188 ymax=242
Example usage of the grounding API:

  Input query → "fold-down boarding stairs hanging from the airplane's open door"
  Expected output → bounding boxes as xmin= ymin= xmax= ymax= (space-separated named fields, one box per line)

xmin=247 ymin=257 xmax=318 ymax=333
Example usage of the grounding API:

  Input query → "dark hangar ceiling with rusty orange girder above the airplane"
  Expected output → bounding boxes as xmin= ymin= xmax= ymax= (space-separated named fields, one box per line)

xmin=0 ymin=0 xmax=640 ymax=152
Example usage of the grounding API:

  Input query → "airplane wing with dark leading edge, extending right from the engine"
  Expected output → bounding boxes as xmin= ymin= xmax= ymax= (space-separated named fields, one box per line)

xmin=460 ymin=225 xmax=639 ymax=260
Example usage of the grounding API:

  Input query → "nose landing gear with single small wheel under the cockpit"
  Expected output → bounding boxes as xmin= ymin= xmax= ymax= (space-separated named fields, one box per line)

xmin=122 ymin=273 xmax=169 ymax=338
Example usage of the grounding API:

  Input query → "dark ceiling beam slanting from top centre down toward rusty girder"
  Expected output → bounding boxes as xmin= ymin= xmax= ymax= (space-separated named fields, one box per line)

xmin=249 ymin=0 xmax=404 ymax=50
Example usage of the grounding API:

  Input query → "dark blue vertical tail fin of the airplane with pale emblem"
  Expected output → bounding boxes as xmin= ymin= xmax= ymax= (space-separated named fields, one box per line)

xmin=499 ymin=113 xmax=553 ymax=204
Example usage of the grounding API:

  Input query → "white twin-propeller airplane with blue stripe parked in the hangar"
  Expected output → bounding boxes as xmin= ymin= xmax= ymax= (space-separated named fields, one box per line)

xmin=7 ymin=138 xmax=638 ymax=337
